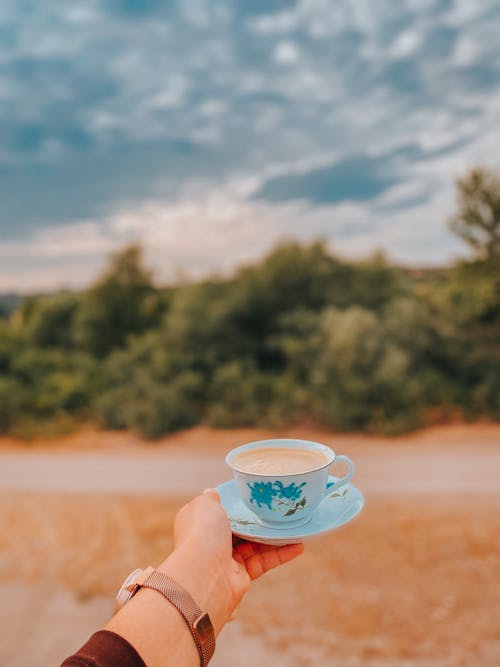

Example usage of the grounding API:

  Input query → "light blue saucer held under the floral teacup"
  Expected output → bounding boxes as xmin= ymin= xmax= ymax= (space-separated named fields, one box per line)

xmin=217 ymin=476 xmax=365 ymax=546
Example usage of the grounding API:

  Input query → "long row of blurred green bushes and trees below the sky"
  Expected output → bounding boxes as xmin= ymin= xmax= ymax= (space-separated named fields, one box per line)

xmin=0 ymin=202 xmax=500 ymax=438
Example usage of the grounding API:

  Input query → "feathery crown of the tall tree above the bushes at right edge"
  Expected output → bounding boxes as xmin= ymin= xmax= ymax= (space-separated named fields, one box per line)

xmin=450 ymin=167 xmax=500 ymax=260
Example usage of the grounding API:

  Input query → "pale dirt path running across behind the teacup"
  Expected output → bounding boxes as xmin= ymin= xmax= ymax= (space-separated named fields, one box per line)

xmin=0 ymin=426 xmax=500 ymax=495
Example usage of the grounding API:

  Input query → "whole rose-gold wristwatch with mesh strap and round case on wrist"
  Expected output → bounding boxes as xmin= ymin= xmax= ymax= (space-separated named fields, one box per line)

xmin=116 ymin=566 xmax=215 ymax=667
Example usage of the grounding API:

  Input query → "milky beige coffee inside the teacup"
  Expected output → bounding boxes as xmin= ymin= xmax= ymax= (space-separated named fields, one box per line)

xmin=231 ymin=447 xmax=330 ymax=475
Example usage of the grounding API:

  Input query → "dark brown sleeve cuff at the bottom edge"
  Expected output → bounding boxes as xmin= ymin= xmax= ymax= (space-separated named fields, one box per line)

xmin=61 ymin=630 xmax=146 ymax=667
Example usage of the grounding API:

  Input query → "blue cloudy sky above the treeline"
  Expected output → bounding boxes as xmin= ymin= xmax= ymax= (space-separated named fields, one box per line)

xmin=0 ymin=0 xmax=500 ymax=292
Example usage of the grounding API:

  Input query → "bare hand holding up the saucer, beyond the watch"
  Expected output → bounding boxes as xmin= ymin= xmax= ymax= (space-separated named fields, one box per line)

xmin=166 ymin=489 xmax=303 ymax=632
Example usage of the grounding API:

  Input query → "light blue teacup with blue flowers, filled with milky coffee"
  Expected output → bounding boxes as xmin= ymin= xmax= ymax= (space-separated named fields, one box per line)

xmin=226 ymin=439 xmax=354 ymax=528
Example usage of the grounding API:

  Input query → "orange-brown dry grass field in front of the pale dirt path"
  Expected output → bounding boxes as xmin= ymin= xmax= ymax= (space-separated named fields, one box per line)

xmin=0 ymin=426 xmax=500 ymax=667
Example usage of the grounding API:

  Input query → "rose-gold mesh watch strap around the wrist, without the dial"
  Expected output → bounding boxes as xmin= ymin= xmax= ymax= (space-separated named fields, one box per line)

xmin=137 ymin=568 xmax=215 ymax=667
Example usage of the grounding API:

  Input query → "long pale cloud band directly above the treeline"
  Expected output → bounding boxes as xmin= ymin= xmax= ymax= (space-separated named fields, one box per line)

xmin=0 ymin=161 xmax=472 ymax=292
